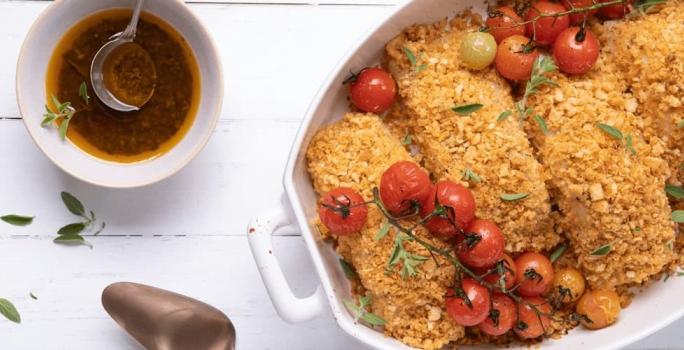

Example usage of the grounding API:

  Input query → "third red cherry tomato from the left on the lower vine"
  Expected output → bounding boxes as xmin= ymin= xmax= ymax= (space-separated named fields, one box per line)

xmin=420 ymin=180 xmax=475 ymax=239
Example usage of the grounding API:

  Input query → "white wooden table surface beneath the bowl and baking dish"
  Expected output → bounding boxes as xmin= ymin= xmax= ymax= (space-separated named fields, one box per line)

xmin=0 ymin=0 xmax=684 ymax=350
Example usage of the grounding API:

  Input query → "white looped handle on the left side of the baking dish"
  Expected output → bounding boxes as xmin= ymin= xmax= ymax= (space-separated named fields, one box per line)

xmin=247 ymin=207 xmax=325 ymax=323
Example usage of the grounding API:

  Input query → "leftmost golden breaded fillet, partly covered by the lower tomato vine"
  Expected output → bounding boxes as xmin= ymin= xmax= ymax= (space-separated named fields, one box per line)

xmin=306 ymin=113 xmax=464 ymax=349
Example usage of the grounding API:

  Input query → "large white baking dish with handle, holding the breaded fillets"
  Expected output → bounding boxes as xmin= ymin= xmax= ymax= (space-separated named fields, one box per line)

xmin=248 ymin=0 xmax=684 ymax=350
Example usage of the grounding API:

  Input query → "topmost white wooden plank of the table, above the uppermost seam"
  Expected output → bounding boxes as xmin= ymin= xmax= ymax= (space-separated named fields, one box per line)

xmin=0 ymin=1 xmax=392 ymax=119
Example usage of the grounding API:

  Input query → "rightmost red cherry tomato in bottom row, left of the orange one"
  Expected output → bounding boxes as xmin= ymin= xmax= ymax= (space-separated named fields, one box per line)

xmin=513 ymin=297 xmax=553 ymax=339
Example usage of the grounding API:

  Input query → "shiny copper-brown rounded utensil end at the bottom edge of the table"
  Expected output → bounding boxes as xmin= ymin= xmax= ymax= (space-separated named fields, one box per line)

xmin=102 ymin=282 xmax=235 ymax=350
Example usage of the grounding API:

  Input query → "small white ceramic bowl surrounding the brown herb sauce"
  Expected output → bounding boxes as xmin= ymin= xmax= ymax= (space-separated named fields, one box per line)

xmin=16 ymin=0 xmax=223 ymax=188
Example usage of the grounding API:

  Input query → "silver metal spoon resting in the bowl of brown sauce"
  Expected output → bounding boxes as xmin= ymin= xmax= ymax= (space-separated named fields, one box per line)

xmin=90 ymin=0 xmax=156 ymax=112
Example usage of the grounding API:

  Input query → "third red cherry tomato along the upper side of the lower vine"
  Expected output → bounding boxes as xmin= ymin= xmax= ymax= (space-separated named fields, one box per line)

xmin=456 ymin=219 xmax=506 ymax=268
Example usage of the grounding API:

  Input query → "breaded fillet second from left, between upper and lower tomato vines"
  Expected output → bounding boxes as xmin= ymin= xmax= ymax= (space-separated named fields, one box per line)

xmin=386 ymin=19 xmax=559 ymax=252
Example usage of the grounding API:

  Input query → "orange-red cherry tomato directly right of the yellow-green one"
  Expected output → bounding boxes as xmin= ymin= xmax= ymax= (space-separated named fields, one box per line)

xmin=494 ymin=35 xmax=539 ymax=80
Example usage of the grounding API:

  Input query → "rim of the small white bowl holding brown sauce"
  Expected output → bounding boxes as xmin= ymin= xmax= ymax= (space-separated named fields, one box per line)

xmin=15 ymin=0 xmax=225 ymax=189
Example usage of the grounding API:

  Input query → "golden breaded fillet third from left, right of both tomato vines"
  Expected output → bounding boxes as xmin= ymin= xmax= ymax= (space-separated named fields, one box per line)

xmin=530 ymin=55 xmax=675 ymax=288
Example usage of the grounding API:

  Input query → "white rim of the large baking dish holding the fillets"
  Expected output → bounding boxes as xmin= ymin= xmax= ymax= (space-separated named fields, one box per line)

xmin=282 ymin=0 xmax=684 ymax=350
